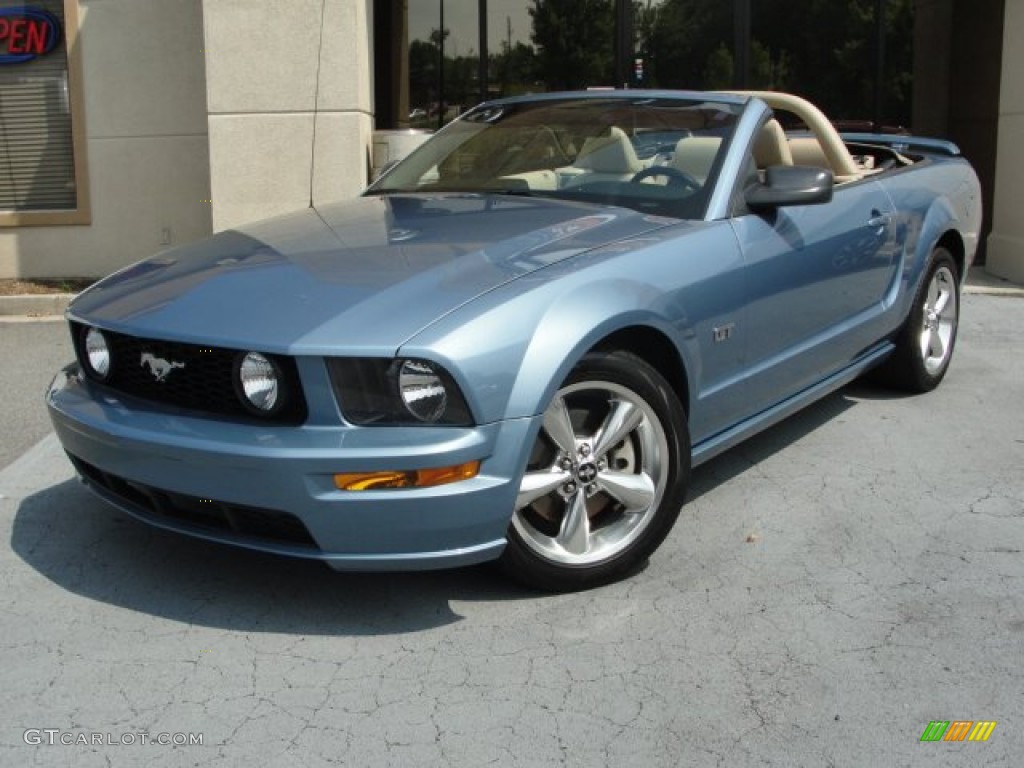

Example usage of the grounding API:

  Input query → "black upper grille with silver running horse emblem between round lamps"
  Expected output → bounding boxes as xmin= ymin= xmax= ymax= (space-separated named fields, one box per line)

xmin=72 ymin=323 xmax=306 ymax=425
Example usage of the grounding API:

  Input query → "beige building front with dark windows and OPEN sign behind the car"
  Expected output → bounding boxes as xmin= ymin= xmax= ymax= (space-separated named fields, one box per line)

xmin=0 ymin=0 xmax=1024 ymax=282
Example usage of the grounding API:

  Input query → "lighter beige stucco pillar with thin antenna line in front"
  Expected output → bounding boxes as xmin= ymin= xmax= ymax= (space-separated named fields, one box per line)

xmin=203 ymin=0 xmax=373 ymax=230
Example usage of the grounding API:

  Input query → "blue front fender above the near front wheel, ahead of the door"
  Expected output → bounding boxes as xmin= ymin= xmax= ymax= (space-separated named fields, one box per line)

xmin=400 ymin=222 xmax=743 ymax=430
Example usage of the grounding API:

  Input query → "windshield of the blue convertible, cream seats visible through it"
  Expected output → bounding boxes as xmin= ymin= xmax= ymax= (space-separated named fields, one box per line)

xmin=367 ymin=93 xmax=742 ymax=218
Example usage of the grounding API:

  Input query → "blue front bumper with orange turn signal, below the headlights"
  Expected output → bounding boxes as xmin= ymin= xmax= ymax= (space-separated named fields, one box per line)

xmin=46 ymin=365 xmax=540 ymax=570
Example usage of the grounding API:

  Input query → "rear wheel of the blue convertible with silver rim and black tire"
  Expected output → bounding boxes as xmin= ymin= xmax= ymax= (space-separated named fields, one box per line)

xmin=870 ymin=247 xmax=961 ymax=392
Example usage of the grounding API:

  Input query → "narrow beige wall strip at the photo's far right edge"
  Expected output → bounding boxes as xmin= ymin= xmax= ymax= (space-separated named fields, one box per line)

xmin=986 ymin=0 xmax=1024 ymax=284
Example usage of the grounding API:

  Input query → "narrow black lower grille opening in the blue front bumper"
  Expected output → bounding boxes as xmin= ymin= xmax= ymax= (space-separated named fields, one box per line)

xmin=68 ymin=454 xmax=318 ymax=550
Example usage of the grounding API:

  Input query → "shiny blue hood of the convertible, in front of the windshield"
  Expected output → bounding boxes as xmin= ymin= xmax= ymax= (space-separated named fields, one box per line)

xmin=69 ymin=195 xmax=673 ymax=354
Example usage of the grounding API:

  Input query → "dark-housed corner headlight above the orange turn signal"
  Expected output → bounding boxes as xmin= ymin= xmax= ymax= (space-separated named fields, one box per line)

xmin=328 ymin=357 xmax=473 ymax=426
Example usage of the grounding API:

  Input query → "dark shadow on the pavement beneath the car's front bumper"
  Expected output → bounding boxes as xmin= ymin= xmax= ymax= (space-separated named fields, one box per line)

xmin=11 ymin=480 xmax=537 ymax=636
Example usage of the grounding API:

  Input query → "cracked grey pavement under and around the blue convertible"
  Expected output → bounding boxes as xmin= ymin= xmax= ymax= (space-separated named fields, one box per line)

xmin=0 ymin=295 xmax=1024 ymax=768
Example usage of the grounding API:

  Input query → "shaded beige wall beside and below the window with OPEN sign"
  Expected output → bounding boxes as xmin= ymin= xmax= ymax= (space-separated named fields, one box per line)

xmin=0 ymin=0 xmax=211 ymax=278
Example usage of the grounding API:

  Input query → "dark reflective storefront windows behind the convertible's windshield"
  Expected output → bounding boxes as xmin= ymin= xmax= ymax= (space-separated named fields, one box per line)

xmin=375 ymin=0 xmax=914 ymax=129
